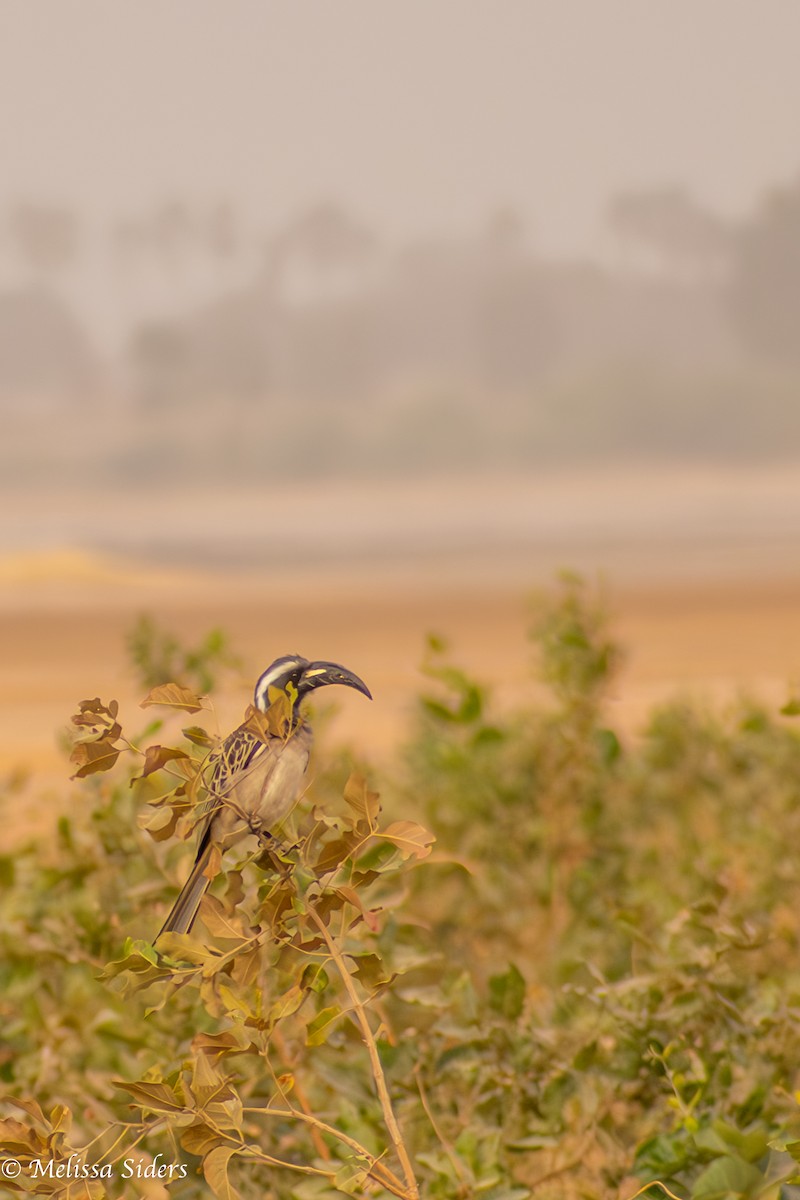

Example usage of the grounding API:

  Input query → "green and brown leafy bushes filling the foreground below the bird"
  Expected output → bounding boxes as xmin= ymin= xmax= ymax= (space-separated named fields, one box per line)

xmin=0 ymin=580 xmax=800 ymax=1200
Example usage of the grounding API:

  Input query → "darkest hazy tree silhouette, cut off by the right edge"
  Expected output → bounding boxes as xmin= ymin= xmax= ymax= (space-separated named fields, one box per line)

xmin=729 ymin=179 xmax=800 ymax=362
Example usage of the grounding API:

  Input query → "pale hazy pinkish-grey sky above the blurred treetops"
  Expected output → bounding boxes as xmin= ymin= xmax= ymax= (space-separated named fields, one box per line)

xmin=0 ymin=0 xmax=800 ymax=251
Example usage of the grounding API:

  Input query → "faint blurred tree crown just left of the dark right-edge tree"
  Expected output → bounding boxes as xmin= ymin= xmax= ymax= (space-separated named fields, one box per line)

xmin=607 ymin=187 xmax=732 ymax=277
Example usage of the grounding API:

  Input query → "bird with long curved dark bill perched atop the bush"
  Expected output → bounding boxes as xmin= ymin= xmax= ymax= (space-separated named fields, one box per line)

xmin=156 ymin=654 xmax=372 ymax=941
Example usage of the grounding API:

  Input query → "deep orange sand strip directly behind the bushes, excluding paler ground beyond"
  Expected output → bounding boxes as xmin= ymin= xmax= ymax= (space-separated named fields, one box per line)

xmin=0 ymin=544 xmax=800 ymax=840
